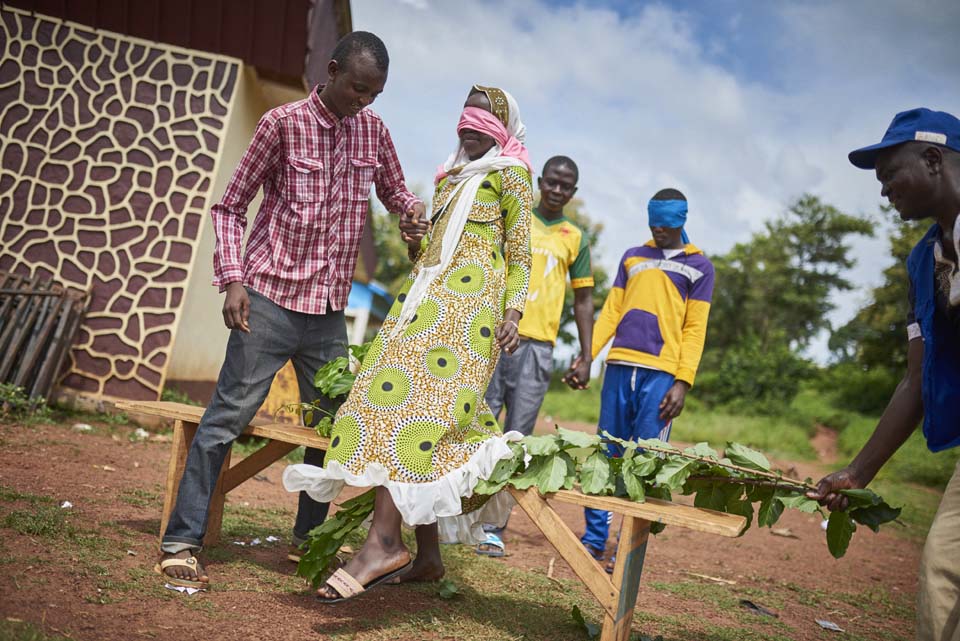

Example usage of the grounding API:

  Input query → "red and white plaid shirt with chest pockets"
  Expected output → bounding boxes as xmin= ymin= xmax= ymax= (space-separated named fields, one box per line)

xmin=211 ymin=89 xmax=419 ymax=314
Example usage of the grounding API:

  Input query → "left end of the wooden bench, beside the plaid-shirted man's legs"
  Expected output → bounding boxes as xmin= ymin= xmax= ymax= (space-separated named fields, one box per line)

xmin=116 ymin=401 xmax=330 ymax=545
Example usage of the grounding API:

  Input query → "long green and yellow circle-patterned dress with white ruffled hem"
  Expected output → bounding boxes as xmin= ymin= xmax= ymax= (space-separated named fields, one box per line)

xmin=284 ymin=167 xmax=533 ymax=542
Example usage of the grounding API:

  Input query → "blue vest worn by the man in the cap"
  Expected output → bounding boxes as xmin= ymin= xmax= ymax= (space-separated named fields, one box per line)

xmin=907 ymin=223 xmax=960 ymax=452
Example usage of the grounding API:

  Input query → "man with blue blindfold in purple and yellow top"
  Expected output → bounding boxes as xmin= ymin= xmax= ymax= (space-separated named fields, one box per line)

xmin=581 ymin=189 xmax=714 ymax=571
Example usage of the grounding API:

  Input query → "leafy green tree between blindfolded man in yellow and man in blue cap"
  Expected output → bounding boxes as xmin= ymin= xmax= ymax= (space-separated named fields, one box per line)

xmin=698 ymin=194 xmax=873 ymax=412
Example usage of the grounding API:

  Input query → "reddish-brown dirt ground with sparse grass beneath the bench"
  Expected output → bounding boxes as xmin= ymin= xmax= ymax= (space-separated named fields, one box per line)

xmin=0 ymin=416 xmax=922 ymax=641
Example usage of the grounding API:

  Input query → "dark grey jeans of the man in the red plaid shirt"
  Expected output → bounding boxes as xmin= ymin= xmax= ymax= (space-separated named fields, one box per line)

xmin=161 ymin=288 xmax=347 ymax=553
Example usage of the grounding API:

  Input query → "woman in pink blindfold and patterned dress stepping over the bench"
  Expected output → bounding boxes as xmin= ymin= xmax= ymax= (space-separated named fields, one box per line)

xmin=283 ymin=86 xmax=533 ymax=602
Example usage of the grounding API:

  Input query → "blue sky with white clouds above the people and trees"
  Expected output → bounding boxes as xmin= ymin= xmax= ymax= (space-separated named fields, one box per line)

xmin=351 ymin=0 xmax=960 ymax=358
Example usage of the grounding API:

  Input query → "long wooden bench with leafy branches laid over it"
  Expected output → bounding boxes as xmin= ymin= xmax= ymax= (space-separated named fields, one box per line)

xmin=122 ymin=401 xmax=746 ymax=641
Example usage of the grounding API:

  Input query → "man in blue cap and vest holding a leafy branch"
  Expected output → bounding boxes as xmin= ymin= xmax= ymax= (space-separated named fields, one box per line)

xmin=808 ymin=109 xmax=960 ymax=641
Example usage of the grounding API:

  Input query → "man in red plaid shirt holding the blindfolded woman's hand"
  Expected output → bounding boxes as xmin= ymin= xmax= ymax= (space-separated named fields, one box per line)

xmin=157 ymin=31 xmax=424 ymax=588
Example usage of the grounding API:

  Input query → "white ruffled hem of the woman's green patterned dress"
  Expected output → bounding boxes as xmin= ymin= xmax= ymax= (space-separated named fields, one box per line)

xmin=283 ymin=432 xmax=523 ymax=544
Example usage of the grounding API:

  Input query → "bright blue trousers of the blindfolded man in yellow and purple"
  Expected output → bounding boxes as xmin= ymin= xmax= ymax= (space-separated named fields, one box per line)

xmin=580 ymin=364 xmax=674 ymax=550
